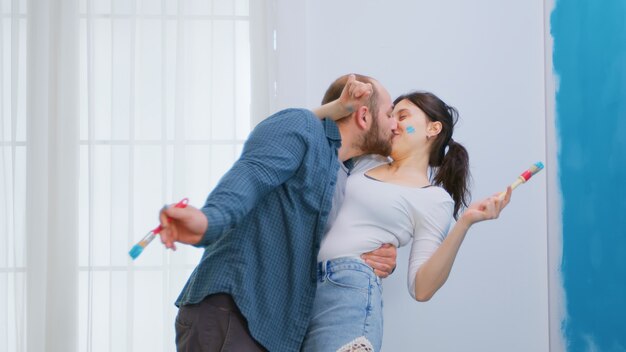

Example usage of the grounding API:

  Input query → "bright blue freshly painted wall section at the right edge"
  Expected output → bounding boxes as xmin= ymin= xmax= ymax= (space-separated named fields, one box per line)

xmin=551 ymin=0 xmax=626 ymax=351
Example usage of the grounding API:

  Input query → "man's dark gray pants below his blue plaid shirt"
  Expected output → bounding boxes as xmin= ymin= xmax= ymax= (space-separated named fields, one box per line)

xmin=176 ymin=293 xmax=266 ymax=352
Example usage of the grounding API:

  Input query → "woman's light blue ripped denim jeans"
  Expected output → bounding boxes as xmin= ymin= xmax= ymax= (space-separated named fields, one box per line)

xmin=302 ymin=258 xmax=383 ymax=352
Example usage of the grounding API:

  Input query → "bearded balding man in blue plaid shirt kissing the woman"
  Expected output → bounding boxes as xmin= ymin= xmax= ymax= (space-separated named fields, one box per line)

xmin=161 ymin=76 xmax=397 ymax=351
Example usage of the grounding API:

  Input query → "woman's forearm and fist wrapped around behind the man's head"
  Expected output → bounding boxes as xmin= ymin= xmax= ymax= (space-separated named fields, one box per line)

xmin=313 ymin=75 xmax=372 ymax=121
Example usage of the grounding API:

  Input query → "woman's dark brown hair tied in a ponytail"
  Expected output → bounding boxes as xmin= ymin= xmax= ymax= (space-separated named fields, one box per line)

xmin=393 ymin=91 xmax=470 ymax=219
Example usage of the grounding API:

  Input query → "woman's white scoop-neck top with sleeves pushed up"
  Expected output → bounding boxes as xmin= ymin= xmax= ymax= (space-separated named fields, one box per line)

xmin=318 ymin=156 xmax=454 ymax=298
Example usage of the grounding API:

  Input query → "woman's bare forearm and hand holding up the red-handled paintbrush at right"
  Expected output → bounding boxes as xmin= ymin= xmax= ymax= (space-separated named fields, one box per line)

xmin=415 ymin=187 xmax=511 ymax=302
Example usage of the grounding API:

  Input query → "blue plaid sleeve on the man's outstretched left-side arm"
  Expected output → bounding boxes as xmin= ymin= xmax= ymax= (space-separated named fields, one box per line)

xmin=196 ymin=109 xmax=312 ymax=247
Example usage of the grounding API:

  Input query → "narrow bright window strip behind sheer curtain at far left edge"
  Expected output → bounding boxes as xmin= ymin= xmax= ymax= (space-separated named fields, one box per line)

xmin=0 ymin=1 xmax=30 ymax=351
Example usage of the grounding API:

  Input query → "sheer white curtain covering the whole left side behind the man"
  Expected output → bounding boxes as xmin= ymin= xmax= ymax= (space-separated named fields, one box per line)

xmin=0 ymin=0 xmax=272 ymax=351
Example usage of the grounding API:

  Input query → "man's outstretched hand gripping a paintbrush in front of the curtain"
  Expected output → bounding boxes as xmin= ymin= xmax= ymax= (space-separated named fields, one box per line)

xmin=159 ymin=206 xmax=209 ymax=250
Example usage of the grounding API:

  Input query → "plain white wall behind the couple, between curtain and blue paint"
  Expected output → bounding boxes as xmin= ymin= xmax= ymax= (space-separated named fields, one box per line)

xmin=274 ymin=0 xmax=550 ymax=352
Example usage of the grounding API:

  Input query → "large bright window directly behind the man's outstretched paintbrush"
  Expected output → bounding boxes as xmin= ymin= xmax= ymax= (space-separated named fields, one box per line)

xmin=78 ymin=0 xmax=250 ymax=351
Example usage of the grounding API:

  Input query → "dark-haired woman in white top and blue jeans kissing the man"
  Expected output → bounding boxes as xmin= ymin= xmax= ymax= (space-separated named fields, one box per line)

xmin=303 ymin=76 xmax=510 ymax=351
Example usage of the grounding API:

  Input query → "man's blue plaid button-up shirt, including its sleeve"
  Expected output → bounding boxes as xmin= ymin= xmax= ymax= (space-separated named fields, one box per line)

xmin=176 ymin=109 xmax=341 ymax=351
